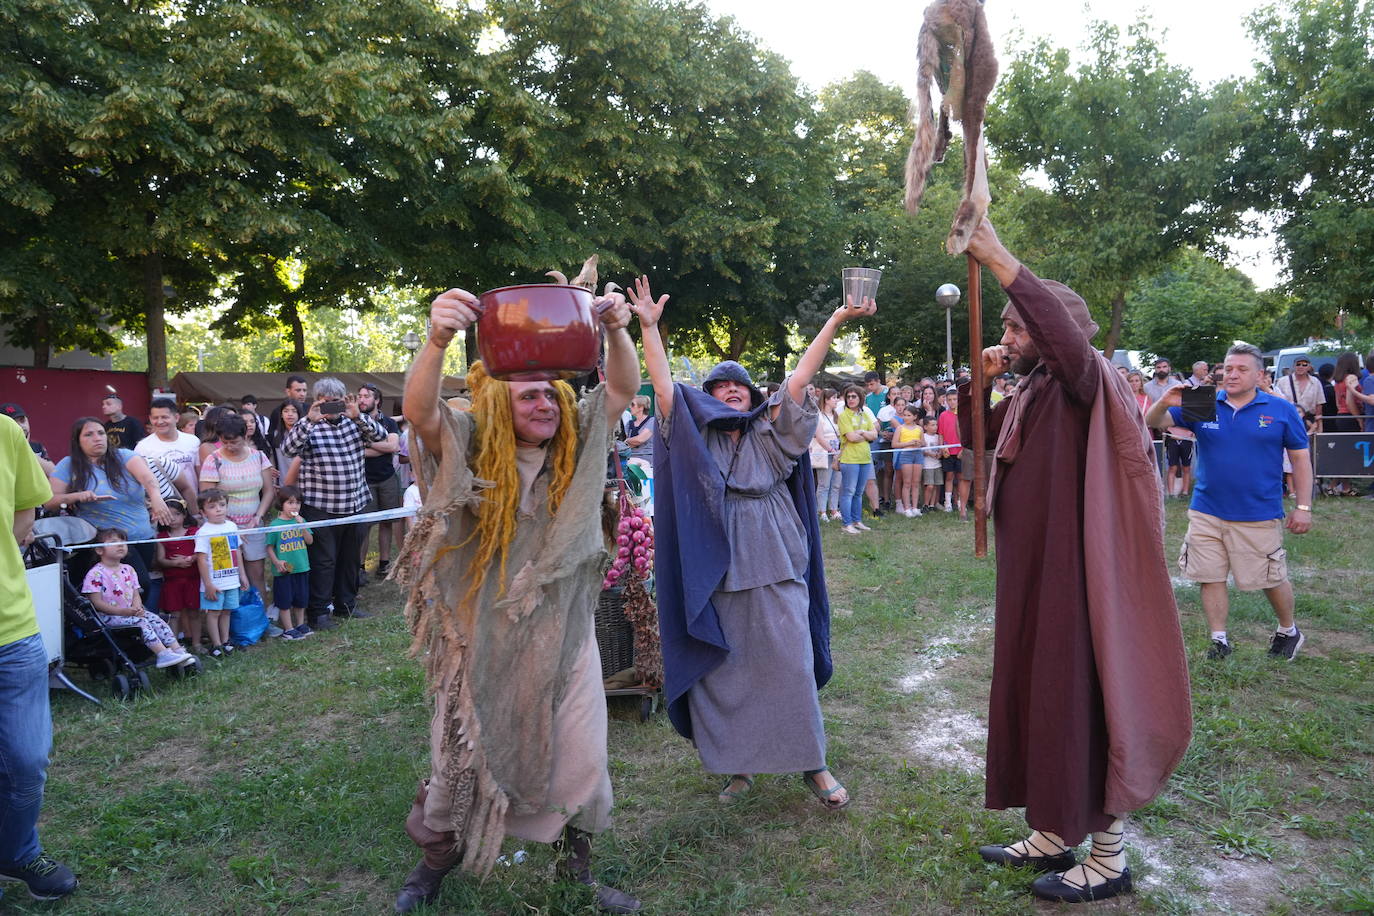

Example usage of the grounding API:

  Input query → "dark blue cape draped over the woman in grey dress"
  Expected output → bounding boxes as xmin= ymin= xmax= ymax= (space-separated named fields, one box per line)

xmin=654 ymin=385 xmax=834 ymax=740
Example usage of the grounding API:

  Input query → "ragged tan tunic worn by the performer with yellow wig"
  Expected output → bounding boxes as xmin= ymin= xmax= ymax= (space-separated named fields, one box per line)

xmin=403 ymin=386 xmax=611 ymax=873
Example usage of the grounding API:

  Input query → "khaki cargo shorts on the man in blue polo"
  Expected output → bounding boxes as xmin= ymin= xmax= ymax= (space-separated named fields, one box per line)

xmin=1179 ymin=509 xmax=1287 ymax=592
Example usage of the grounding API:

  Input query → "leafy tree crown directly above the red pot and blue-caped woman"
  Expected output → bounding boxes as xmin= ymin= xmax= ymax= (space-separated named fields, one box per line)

xmin=474 ymin=0 xmax=842 ymax=373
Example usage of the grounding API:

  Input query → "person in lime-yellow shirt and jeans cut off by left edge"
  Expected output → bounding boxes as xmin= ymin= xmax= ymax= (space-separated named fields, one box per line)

xmin=0 ymin=415 xmax=77 ymax=900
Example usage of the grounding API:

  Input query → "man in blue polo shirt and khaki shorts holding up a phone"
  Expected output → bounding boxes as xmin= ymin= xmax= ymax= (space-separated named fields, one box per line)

xmin=1145 ymin=343 xmax=1312 ymax=661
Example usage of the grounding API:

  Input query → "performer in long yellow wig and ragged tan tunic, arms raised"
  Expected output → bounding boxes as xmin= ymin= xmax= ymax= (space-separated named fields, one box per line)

xmin=393 ymin=290 xmax=639 ymax=913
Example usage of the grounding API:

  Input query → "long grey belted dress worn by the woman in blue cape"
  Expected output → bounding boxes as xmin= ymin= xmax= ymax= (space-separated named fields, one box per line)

xmin=665 ymin=387 xmax=826 ymax=773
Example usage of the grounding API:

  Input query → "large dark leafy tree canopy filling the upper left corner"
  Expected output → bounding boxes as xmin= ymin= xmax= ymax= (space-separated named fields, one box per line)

xmin=0 ymin=0 xmax=503 ymax=385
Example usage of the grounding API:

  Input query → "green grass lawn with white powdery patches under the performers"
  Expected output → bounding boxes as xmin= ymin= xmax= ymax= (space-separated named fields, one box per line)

xmin=13 ymin=500 xmax=1374 ymax=916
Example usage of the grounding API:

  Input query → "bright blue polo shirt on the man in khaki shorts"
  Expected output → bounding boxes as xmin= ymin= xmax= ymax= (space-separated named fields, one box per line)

xmin=1169 ymin=389 xmax=1308 ymax=522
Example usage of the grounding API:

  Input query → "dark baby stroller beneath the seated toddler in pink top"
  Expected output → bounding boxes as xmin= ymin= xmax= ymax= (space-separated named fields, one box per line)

xmin=25 ymin=516 xmax=203 ymax=702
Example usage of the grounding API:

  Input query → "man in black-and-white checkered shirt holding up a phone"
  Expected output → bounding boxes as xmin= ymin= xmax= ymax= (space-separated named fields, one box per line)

xmin=282 ymin=378 xmax=386 ymax=629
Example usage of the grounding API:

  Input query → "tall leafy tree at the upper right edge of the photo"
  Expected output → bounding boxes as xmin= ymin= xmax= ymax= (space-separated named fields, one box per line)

xmin=1235 ymin=0 xmax=1374 ymax=329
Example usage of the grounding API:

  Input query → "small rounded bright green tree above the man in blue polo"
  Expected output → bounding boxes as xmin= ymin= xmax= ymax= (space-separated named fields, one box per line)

xmin=1124 ymin=249 xmax=1261 ymax=367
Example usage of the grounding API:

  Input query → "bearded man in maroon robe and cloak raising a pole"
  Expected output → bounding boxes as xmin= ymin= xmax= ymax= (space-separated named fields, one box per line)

xmin=959 ymin=220 xmax=1191 ymax=902
